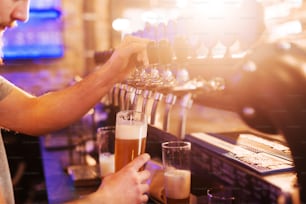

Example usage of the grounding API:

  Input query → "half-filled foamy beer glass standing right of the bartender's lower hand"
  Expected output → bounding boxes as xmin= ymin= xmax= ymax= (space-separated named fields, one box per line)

xmin=162 ymin=141 xmax=191 ymax=204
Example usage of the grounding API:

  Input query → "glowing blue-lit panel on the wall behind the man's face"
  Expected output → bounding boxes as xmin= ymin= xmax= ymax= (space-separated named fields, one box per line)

xmin=3 ymin=0 xmax=64 ymax=60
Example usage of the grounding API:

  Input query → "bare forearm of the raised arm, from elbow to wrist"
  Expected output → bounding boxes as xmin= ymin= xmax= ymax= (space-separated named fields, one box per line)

xmin=2 ymin=64 xmax=116 ymax=135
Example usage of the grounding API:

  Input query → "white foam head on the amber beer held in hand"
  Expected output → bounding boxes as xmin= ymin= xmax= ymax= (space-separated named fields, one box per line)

xmin=116 ymin=123 xmax=147 ymax=140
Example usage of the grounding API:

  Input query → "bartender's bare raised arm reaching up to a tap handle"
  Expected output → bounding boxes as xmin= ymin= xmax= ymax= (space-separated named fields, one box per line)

xmin=0 ymin=36 xmax=148 ymax=135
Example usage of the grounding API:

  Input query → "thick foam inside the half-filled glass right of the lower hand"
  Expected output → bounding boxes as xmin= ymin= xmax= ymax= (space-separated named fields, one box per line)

xmin=164 ymin=169 xmax=191 ymax=199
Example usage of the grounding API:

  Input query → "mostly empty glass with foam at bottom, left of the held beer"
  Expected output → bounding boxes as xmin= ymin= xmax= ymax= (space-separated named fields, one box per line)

xmin=97 ymin=126 xmax=115 ymax=178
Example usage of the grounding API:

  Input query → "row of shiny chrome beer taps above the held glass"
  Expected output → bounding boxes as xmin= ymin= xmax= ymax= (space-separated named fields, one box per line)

xmin=100 ymin=39 xmax=224 ymax=139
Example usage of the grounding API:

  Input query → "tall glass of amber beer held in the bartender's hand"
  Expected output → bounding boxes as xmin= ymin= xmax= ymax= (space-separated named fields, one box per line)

xmin=115 ymin=110 xmax=148 ymax=171
